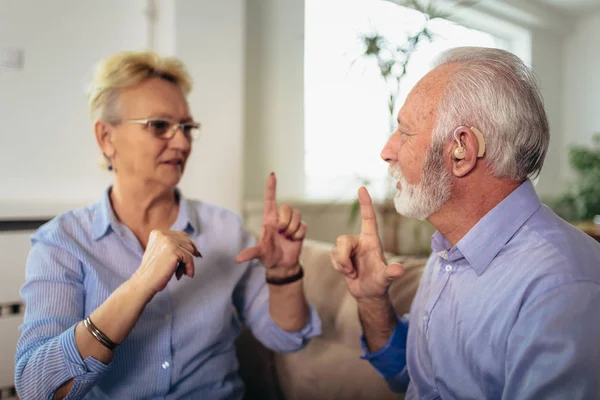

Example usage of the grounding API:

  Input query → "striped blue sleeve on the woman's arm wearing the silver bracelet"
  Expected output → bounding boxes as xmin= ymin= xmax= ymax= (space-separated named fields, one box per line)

xmin=15 ymin=236 xmax=109 ymax=399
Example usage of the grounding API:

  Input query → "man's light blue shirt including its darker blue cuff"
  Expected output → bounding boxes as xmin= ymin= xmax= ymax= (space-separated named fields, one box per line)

xmin=362 ymin=181 xmax=600 ymax=400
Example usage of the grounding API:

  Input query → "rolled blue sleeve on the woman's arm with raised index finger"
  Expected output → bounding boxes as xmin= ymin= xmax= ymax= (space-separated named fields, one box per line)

xmin=233 ymin=234 xmax=321 ymax=353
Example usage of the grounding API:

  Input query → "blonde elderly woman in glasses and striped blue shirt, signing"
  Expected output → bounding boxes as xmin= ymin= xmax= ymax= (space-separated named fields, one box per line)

xmin=15 ymin=52 xmax=320 ymax=399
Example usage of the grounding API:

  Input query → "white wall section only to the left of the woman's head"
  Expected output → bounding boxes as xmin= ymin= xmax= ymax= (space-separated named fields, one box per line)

xmin=0 ymin=0 xmax=147 ymax=206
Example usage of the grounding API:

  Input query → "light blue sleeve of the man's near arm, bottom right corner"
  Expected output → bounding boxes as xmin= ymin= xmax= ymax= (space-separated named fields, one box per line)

xmin=502 ymin=281 xmax=600 ymax=400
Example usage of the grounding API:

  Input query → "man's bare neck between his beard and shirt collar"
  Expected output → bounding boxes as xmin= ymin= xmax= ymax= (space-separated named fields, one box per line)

xmin=428 ymin=177 xmax=520 ymax=247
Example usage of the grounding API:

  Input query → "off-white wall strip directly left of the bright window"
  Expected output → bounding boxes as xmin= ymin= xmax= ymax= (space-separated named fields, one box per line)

xmin=244 ymin=0 xmax=304 ymax=199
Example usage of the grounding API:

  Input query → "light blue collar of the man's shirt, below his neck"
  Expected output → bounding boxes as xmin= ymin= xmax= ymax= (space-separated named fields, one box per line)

xmin=431 ymin=180 xmax=541 ymax=275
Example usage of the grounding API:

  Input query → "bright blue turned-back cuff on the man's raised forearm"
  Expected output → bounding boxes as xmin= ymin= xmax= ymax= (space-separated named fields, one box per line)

xmin=360 ymin=315 xmax=410 ymax=392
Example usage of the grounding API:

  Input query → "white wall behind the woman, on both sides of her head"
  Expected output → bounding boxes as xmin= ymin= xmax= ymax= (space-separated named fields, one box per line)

xmin=0 ymin=0 xmax=245 ymax=214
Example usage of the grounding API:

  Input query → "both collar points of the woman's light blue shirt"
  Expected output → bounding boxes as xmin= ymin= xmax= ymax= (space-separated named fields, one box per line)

xmin=92 ymin=186 xmax=198 ymax=240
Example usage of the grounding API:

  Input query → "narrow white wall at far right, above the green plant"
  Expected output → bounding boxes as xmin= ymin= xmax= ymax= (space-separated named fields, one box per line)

xmin=562 ymin=13 xmax=600 ymax=177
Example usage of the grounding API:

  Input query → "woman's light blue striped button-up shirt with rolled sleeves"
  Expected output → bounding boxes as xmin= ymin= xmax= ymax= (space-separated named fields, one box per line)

xmin=15 ymin=190 xmax=321 ymax=399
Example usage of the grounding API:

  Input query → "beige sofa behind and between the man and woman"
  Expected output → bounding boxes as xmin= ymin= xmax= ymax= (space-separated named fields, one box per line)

xmin=236 ymin=239 xmax=427 ymax=400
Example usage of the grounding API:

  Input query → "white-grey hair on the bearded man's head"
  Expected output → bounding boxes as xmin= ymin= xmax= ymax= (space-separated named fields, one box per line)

xmin=433 ymin=47 xmax=550 ymax=182
